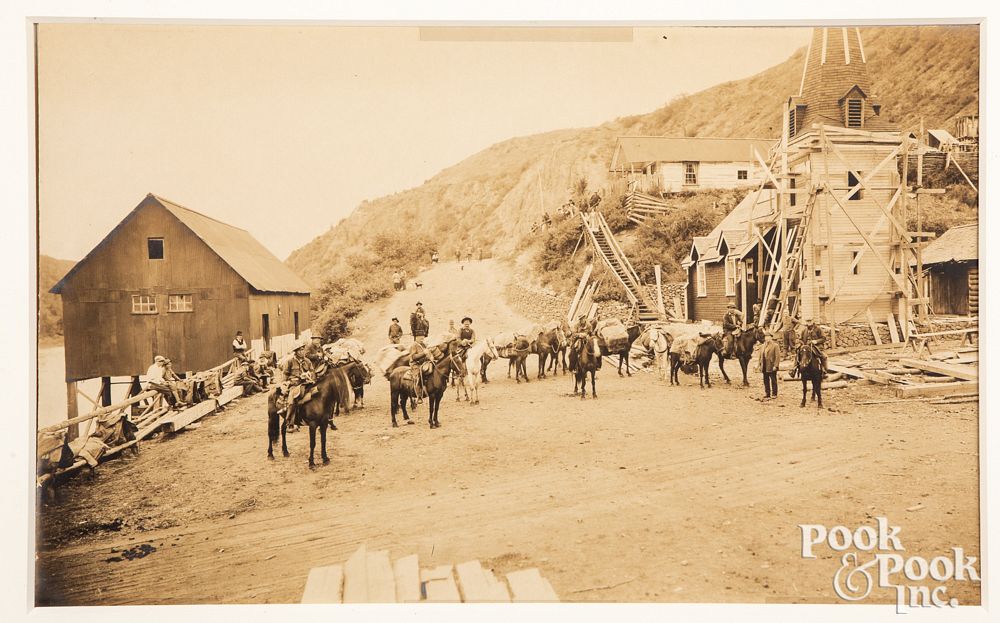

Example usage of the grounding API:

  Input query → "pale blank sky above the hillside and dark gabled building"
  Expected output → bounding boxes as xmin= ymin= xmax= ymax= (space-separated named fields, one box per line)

xmin=38 ymin=23 xmax=810 ymax=260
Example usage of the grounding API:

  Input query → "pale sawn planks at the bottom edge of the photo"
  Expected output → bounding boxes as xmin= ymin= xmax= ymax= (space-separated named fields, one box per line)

xmin=301 ymin=544 xmax=559 ymax=604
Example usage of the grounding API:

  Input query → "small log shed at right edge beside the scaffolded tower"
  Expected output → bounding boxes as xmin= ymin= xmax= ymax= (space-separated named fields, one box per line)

xmin=922 ymin=223 xmax=979 ymax=316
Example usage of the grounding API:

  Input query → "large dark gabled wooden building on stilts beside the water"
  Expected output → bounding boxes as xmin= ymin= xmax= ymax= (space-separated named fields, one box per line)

xmin=51 ymin=194 xmax=310 ymax=382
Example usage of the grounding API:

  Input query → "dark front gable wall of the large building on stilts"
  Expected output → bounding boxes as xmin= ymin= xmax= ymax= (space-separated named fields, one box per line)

xmin=61 ymin=202 xmax=249 ymax=380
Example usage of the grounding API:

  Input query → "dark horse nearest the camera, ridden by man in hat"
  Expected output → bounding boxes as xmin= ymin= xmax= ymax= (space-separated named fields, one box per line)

xmin=267 ymin=366 xmax=352 ymax=467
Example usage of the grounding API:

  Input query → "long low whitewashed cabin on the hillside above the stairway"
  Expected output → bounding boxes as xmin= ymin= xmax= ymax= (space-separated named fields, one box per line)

xmin=610 ymin=136 xmax=775 ymax=193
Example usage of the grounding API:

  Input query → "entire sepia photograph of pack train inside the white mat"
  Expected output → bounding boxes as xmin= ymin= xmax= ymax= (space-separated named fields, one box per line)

xmin=19 ymin=3 xmax=987 ymax=620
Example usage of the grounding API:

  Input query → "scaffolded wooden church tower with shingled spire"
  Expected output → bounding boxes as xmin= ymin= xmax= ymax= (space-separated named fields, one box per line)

xmin=758 ymin=27 xmax=925 ymax=330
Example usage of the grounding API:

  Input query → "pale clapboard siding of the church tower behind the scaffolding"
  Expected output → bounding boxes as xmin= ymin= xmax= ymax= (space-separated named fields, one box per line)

xmin=796 ymin=144 xmax=899 ymax=323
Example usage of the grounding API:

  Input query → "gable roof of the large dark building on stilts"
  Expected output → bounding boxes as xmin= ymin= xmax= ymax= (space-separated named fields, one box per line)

xmin=50 ymin=193 xmax=310 ymax=294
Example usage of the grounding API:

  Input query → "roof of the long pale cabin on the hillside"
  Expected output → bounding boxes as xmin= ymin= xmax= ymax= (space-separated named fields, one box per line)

xmin=611 ymin=136 xmax=775 ymax=170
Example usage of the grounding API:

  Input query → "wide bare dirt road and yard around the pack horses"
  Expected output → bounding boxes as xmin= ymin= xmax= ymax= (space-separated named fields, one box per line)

xmin=38 ymin=262 xmax=979 ymax=605
